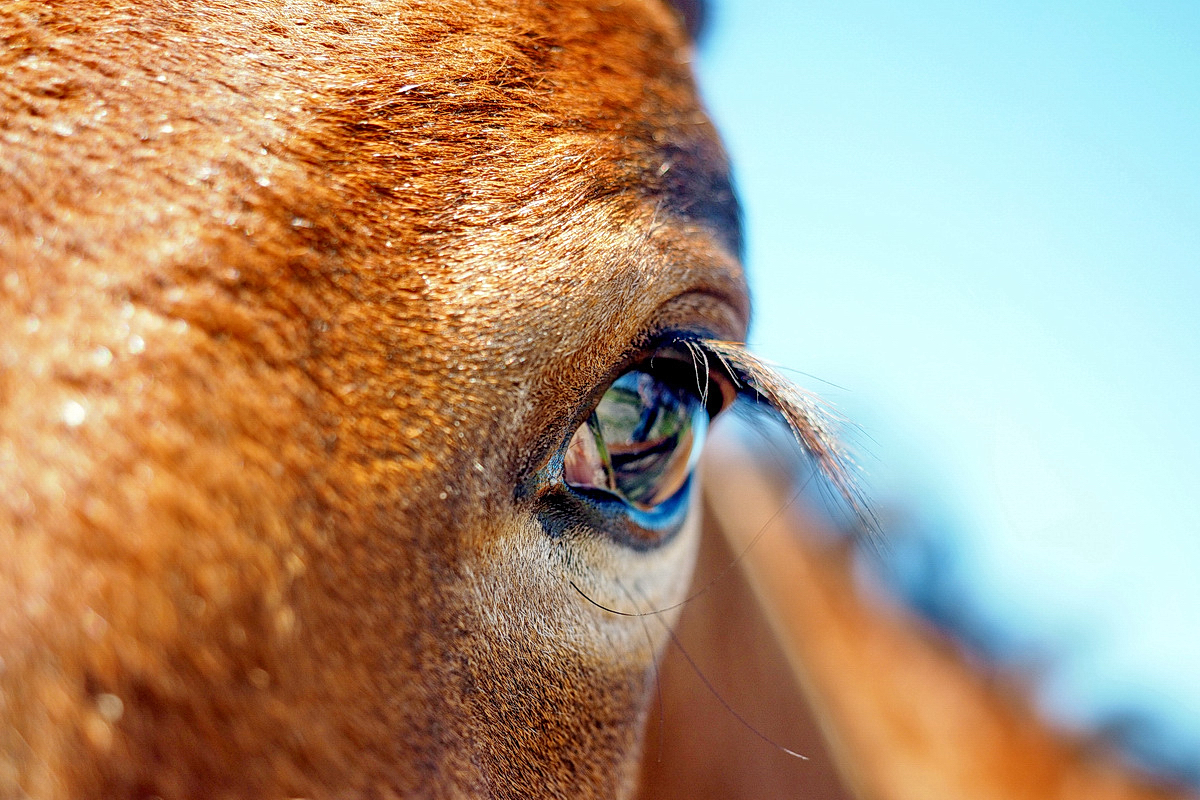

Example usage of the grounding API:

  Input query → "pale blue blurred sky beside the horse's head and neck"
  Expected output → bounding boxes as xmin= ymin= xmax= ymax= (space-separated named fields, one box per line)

xmin=698 ymin=0 xmax=1200 ymax=783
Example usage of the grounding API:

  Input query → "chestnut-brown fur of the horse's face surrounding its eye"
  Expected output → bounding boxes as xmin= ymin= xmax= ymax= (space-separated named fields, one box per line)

xmin=0 ymin=0 xmax=746 ymax=798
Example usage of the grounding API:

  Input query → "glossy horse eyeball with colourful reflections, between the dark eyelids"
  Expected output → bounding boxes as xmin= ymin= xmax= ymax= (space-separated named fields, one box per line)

xmin=563 ymin=369 xmax=708 ymax=511
